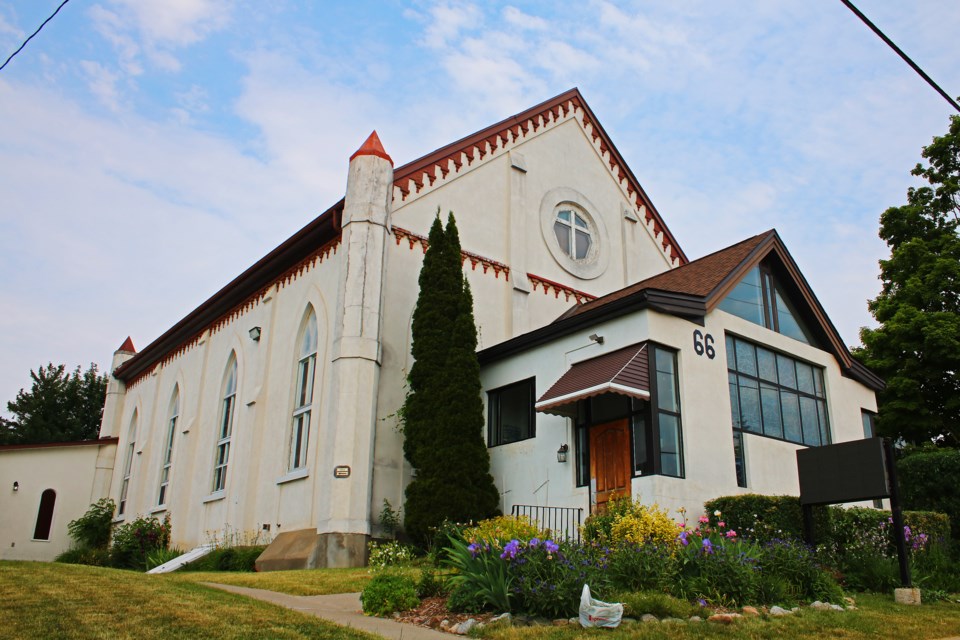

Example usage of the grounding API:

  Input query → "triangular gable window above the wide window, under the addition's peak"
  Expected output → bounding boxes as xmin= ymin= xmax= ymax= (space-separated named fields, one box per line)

xmin=718 ymin=265 xmax=814 ymax=344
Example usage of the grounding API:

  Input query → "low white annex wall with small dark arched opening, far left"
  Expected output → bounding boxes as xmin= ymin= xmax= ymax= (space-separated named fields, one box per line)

xmin=0 ymin=444 xmax=116 ymax=561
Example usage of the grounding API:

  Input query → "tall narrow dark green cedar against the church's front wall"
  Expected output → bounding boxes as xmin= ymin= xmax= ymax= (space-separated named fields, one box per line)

xmin=401 ymin=212 xmax=500 ymax=543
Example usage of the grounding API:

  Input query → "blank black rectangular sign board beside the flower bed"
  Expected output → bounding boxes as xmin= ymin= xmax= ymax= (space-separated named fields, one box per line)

xmin=797 ymin=438 xmax=890 ymax=504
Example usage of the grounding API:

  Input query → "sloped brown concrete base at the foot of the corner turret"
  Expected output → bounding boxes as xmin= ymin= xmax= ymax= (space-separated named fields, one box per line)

xmin=256 ymin=529 xmax=369 ymax=571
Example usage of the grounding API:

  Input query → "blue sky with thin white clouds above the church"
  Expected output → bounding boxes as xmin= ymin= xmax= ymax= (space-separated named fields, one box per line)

xmin=0 ymin=0 xmax=960 ymax=416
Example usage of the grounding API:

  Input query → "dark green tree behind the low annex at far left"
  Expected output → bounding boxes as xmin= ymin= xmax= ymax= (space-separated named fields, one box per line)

xmin=0 ymin=364 xmax=107 ymax=444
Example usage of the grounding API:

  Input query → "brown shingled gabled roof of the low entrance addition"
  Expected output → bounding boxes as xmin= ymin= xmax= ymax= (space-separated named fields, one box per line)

xmin=479 ymin=230 xmax=884 ymax=390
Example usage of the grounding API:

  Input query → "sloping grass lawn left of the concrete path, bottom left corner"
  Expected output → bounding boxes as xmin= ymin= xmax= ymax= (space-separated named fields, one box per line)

xmin=0 ymin=562 xmax=376 ymax=640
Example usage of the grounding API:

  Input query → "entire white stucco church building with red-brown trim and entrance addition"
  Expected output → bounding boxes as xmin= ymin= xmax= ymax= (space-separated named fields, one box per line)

xmin=0 ymin=89 xmax=883 ymax=569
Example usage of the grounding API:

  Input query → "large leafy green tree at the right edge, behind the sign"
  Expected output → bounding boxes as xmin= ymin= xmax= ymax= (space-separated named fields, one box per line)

xmin=856 ymin=116 xmax=960 ymax=447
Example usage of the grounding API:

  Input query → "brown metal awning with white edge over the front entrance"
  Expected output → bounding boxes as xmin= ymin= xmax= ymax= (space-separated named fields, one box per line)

xmin=534 ymin=342 xmax=650 ymax=416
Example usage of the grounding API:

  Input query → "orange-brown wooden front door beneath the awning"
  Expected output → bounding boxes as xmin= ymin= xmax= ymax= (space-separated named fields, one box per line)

xmin=590 ymin=419 xmax=632 ymax=512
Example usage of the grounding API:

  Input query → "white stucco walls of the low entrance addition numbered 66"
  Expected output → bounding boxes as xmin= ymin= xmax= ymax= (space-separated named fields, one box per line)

xmin=482 ymin=311 xmax=876 ymax=514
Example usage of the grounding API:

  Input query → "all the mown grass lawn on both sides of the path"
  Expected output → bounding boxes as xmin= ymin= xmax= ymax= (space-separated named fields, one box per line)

xmin=0 ymin=562 xmax=960 ymax=640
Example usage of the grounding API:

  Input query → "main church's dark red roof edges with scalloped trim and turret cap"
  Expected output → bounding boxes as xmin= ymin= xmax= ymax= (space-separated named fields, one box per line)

xmin=113 ymin=88 xmax=687 ymax=384
